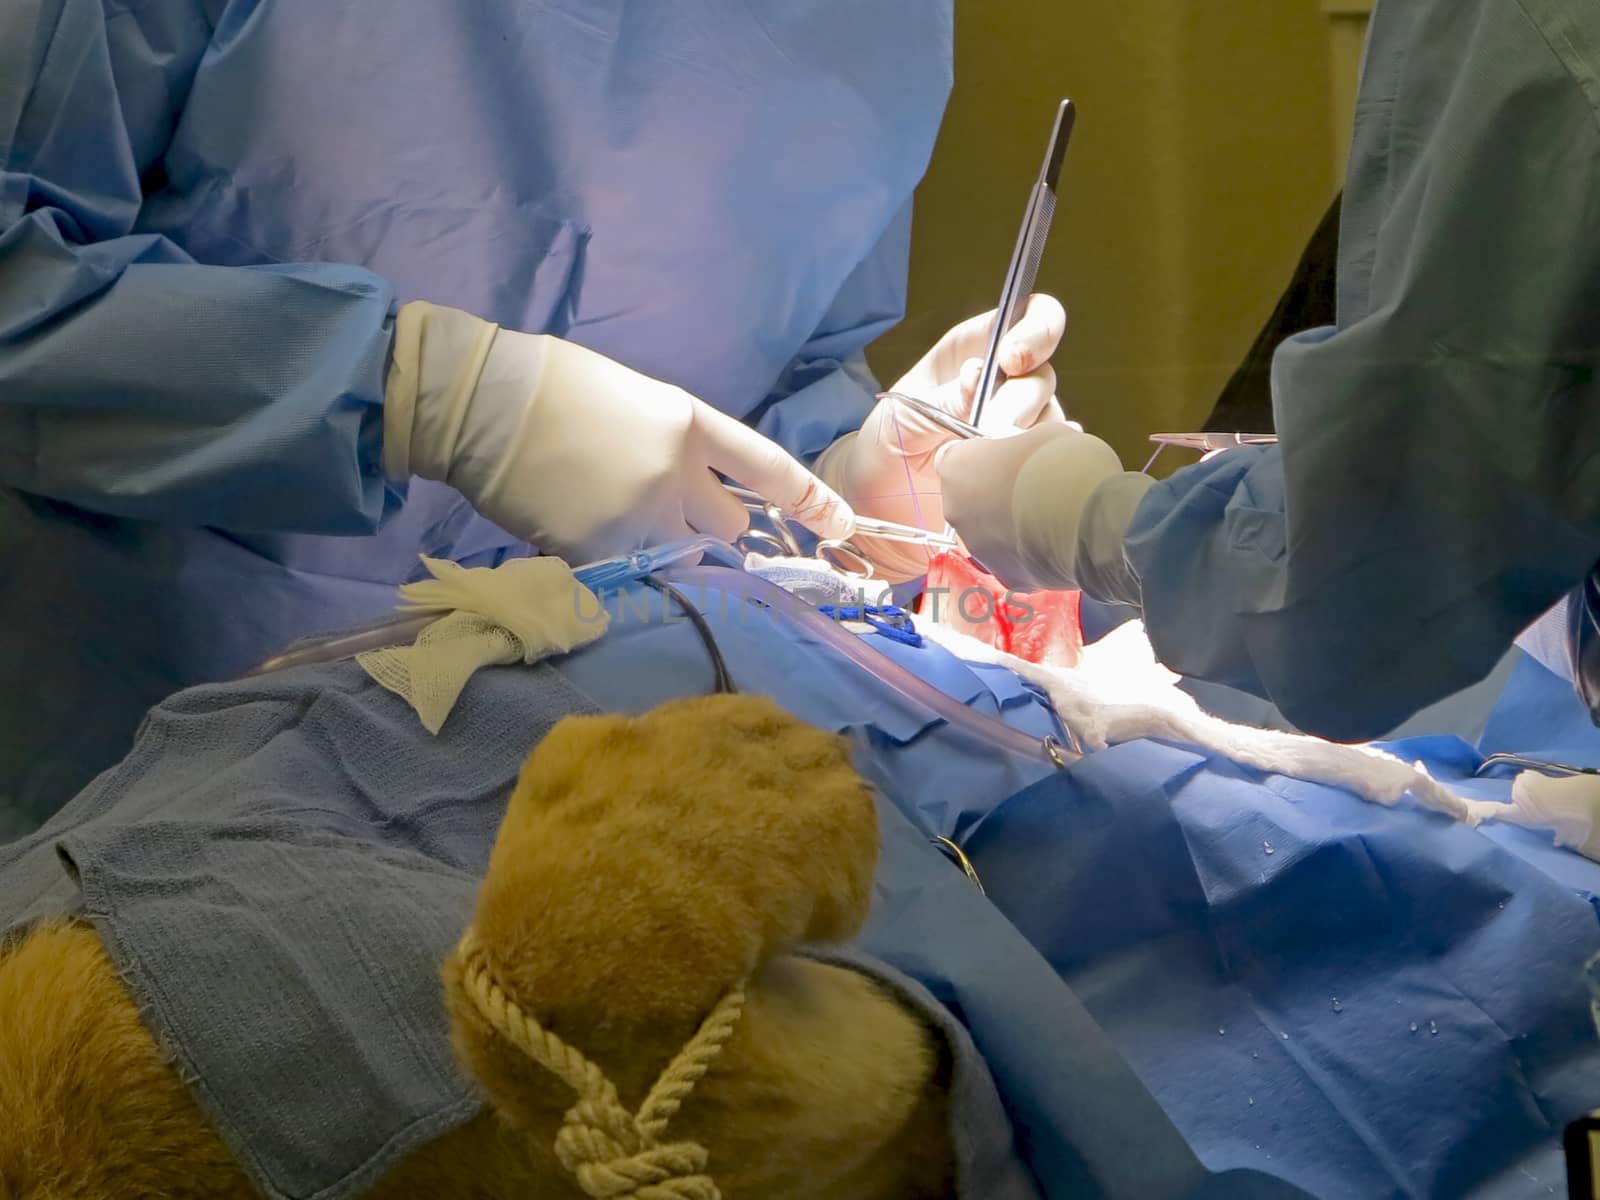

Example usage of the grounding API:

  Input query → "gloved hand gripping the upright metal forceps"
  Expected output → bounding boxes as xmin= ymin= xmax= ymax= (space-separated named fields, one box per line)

xmin=816 ymin=294 xmax=1067 ymax=582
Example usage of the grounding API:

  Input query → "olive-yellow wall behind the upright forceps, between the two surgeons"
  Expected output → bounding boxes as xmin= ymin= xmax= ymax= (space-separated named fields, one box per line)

xmin=869 ymin=0 xmax=1339 ymax=469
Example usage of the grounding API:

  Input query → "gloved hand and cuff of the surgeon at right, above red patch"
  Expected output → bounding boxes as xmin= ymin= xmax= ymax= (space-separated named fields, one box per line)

xmin=939 ymin=424 xmax=1154 ymax=605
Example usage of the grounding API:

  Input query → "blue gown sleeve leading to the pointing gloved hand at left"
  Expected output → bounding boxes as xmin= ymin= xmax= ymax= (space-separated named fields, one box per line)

xmin=0 ymin=0 xmax=397 ymax=534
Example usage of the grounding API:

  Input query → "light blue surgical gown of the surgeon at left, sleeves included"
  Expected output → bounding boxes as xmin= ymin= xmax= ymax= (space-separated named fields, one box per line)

xmin=0 ymin=0 xmax=952 ymax=838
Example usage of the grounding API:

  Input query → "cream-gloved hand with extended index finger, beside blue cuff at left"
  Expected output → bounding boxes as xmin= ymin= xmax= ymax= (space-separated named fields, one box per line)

xmin=384 ymin=301 xmax=854 ymax=565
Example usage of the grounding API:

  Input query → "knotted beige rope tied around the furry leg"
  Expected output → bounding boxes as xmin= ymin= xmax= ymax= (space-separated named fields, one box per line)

xmin=456 ymin=928 xmax=744 ymax=1200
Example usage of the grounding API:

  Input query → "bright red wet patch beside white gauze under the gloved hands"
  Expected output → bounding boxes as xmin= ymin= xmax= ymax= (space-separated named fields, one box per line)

xmin=915 ymin=550 xmax=1083 ymax=667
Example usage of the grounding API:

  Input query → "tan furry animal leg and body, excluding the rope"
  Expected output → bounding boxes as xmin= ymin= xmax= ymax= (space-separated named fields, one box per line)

xmin=0 ymin=696 xmax=954 ymax=1200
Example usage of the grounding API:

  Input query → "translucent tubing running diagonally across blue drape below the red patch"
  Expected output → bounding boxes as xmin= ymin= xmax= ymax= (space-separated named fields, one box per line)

xmin=669 ymin=566 xmax=1083 ymax=766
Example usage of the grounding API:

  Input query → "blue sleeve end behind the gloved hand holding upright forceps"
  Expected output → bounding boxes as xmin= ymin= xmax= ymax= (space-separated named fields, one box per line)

xmin=750 ymin=202 xmax=912 ymax=464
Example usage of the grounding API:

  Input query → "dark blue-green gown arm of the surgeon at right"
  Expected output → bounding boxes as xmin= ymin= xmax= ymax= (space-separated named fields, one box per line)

xmin=1125 ymin=0 xmax=1600 ymax=739
